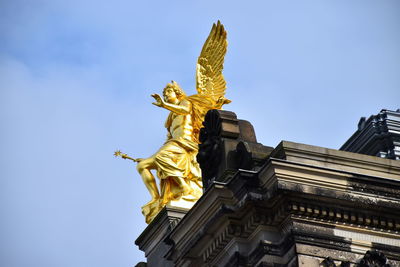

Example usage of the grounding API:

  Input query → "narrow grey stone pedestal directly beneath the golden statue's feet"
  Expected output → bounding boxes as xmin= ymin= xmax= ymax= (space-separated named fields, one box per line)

xmin=135 ymin=203 xmax=190 ymax=267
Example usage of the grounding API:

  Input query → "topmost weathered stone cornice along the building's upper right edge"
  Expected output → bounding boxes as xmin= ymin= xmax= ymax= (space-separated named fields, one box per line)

xmin=268 ymin=159 xmax=400 ymax=203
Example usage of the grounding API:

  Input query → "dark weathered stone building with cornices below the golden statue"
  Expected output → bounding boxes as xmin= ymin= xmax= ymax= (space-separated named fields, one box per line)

xmin=136 ymin=110 xmax=400 ymax=267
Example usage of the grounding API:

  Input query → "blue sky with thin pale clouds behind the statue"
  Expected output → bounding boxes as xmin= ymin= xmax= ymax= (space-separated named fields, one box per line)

xmin=0 ymin=0 xmax=400 ymax=267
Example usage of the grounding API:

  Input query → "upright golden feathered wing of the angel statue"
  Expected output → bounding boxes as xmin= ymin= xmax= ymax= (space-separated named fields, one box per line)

xmin=196 ymin=21 xmax=228 ymax=103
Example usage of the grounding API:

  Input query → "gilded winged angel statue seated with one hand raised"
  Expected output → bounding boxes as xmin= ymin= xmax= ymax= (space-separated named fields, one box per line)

xmin=115 ymin=21 xmax=231 ymax=223
